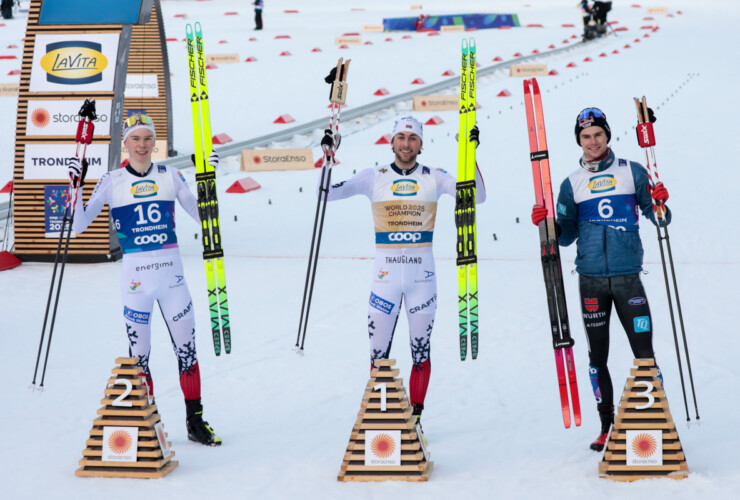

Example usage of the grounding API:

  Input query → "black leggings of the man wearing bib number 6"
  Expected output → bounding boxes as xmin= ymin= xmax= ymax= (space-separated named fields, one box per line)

xmin=579 ymin=274 xmax=655 ymax=409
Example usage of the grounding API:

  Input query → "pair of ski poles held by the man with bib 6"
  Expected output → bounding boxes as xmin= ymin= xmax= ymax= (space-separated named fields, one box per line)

xmin=634 ymin=96 xmax=699 ymax=421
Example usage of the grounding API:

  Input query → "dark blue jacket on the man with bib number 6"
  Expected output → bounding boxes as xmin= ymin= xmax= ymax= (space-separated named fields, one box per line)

xmin=557 ymin=151 xmax=671 ymax=277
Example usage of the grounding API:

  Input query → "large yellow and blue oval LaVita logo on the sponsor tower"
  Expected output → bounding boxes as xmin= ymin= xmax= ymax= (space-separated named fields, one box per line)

xmin=41 ymin=41 xmax=108 ymax=85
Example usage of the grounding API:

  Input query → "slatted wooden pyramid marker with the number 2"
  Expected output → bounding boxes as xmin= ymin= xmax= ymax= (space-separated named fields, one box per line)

xmin=75 ymin=358 xmax=178 ymax=478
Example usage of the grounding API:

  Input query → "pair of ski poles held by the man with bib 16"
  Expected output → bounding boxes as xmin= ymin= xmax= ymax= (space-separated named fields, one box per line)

xmin=31 ymin=99 xmax=97 ymax=390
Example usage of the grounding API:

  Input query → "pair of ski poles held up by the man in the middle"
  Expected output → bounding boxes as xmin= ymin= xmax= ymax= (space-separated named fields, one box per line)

xmin=294 ymin=57 xmax=350 ymax=355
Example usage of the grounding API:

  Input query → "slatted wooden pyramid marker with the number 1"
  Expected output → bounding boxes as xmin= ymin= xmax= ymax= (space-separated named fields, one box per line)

xmin=337 ymin=359 xmax=434 ymax=481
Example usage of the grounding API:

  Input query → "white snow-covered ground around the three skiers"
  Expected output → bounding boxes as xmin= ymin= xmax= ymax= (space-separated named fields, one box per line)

xmin=0 ymin=0 xmax=740 ymax=499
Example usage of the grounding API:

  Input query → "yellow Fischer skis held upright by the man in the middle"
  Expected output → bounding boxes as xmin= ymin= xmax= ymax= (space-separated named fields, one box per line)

xmin=455 ymin=38 xmax=478 ymax=361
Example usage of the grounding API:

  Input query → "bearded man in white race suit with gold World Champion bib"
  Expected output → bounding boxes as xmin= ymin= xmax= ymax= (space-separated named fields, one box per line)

xmin=322 ymin=116 xmax=486 ymax=417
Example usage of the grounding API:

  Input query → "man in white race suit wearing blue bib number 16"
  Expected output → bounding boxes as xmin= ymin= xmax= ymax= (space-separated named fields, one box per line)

xmin=70 ymin=114 xmax=221 ymax=445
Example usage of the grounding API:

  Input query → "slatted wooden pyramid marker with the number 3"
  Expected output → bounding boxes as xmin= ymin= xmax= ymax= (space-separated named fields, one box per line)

xmin=599 ymin=359 xmax=689 ymax=481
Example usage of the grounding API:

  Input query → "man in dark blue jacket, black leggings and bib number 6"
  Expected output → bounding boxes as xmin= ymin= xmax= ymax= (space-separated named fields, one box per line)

xmin=532 ymin=108 xmax=671 ymax=451
